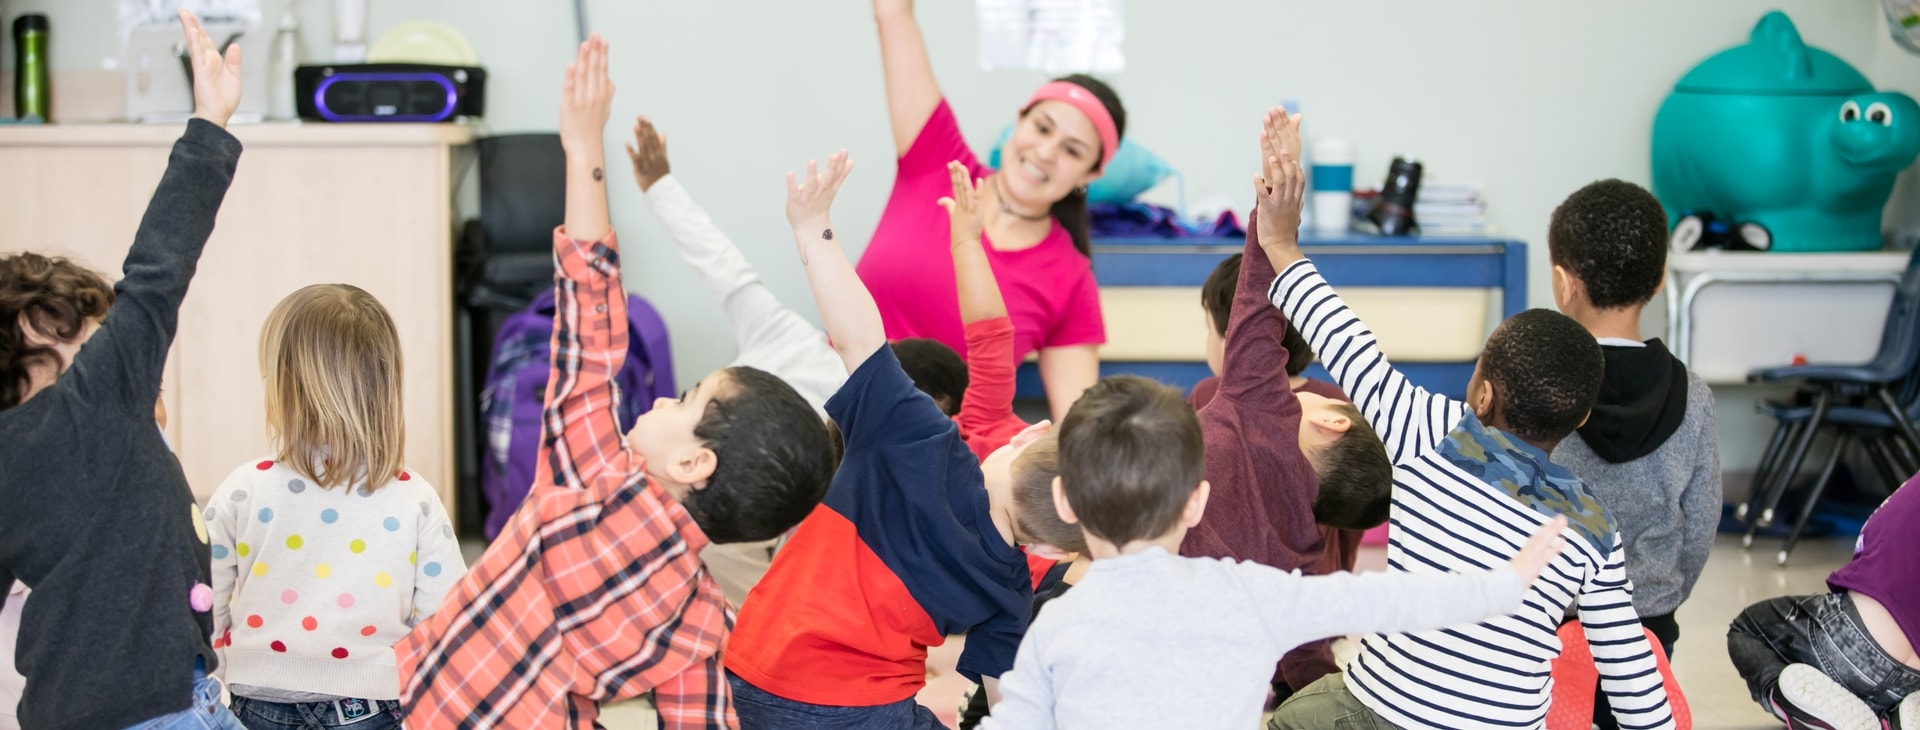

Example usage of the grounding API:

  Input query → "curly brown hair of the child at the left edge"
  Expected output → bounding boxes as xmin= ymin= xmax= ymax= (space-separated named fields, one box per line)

xmin=0 ymin=254 xmax=113 ymax=411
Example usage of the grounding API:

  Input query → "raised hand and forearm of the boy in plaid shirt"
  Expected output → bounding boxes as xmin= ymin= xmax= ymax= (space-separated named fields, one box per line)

xmin=561 ymin=33 xmax=612 ymax=240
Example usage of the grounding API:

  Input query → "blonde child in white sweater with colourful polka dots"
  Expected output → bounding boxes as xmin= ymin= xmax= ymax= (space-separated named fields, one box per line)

xmin=205 ymin=284 xmax=467 ymax=730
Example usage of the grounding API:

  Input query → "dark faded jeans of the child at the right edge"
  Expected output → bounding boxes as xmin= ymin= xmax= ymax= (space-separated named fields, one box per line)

xmin=1726 ymin=592 xmax=1920 ymax=715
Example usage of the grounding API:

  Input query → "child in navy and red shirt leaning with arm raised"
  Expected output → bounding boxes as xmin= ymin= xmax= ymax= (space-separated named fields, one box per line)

xmin=726 ymin=152 xmax=1064 ymax=728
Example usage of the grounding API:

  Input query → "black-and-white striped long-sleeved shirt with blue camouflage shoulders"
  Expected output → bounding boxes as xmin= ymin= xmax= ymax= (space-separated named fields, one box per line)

xmin=1267 ymin=261 xmax=1674 ymax=730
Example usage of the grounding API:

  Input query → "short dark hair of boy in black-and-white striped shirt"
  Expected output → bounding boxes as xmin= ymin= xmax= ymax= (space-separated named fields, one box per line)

xmin=1480 ymin=309 xmax=1607 ymax=444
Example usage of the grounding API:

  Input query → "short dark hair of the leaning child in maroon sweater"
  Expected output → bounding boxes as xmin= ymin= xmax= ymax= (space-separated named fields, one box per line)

xmin=1300 ymin=403 xmax=1394 ymax=530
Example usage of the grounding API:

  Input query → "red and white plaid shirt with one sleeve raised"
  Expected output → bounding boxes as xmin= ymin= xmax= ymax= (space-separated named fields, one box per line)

xmin=394 ymin=229 xmax=737 ymax=730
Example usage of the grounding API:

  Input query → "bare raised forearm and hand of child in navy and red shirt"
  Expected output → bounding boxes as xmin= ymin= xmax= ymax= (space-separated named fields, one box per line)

xmin=787 ymin=150 xmax=887 ymax=373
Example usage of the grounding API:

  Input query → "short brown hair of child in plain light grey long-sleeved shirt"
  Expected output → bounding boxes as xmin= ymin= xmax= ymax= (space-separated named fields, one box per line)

xmin=1060 ymin=375 xmax=1206 ymax=546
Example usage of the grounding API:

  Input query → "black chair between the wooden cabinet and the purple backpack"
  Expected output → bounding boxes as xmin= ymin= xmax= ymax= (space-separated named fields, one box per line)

xmin=453 ymin=134 xmax=566 ymax=534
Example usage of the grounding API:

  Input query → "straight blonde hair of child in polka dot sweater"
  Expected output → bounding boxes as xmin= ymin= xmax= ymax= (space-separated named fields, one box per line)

xmin=259 ymin=284 xmax=407 ymax=490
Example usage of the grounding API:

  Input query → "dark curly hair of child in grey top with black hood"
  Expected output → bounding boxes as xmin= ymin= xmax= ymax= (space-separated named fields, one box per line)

xmin=1548 ymin=181 xmax=1667 ymax=309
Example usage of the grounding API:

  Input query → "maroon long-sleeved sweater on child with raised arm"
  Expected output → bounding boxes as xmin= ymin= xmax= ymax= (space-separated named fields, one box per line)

xmin=1181 ymin=217 xmax=1340 ymax=690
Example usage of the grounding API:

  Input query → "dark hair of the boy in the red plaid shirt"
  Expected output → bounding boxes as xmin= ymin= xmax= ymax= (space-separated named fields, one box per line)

xmin=680 ymin=367 xmax=839 ymax=544
